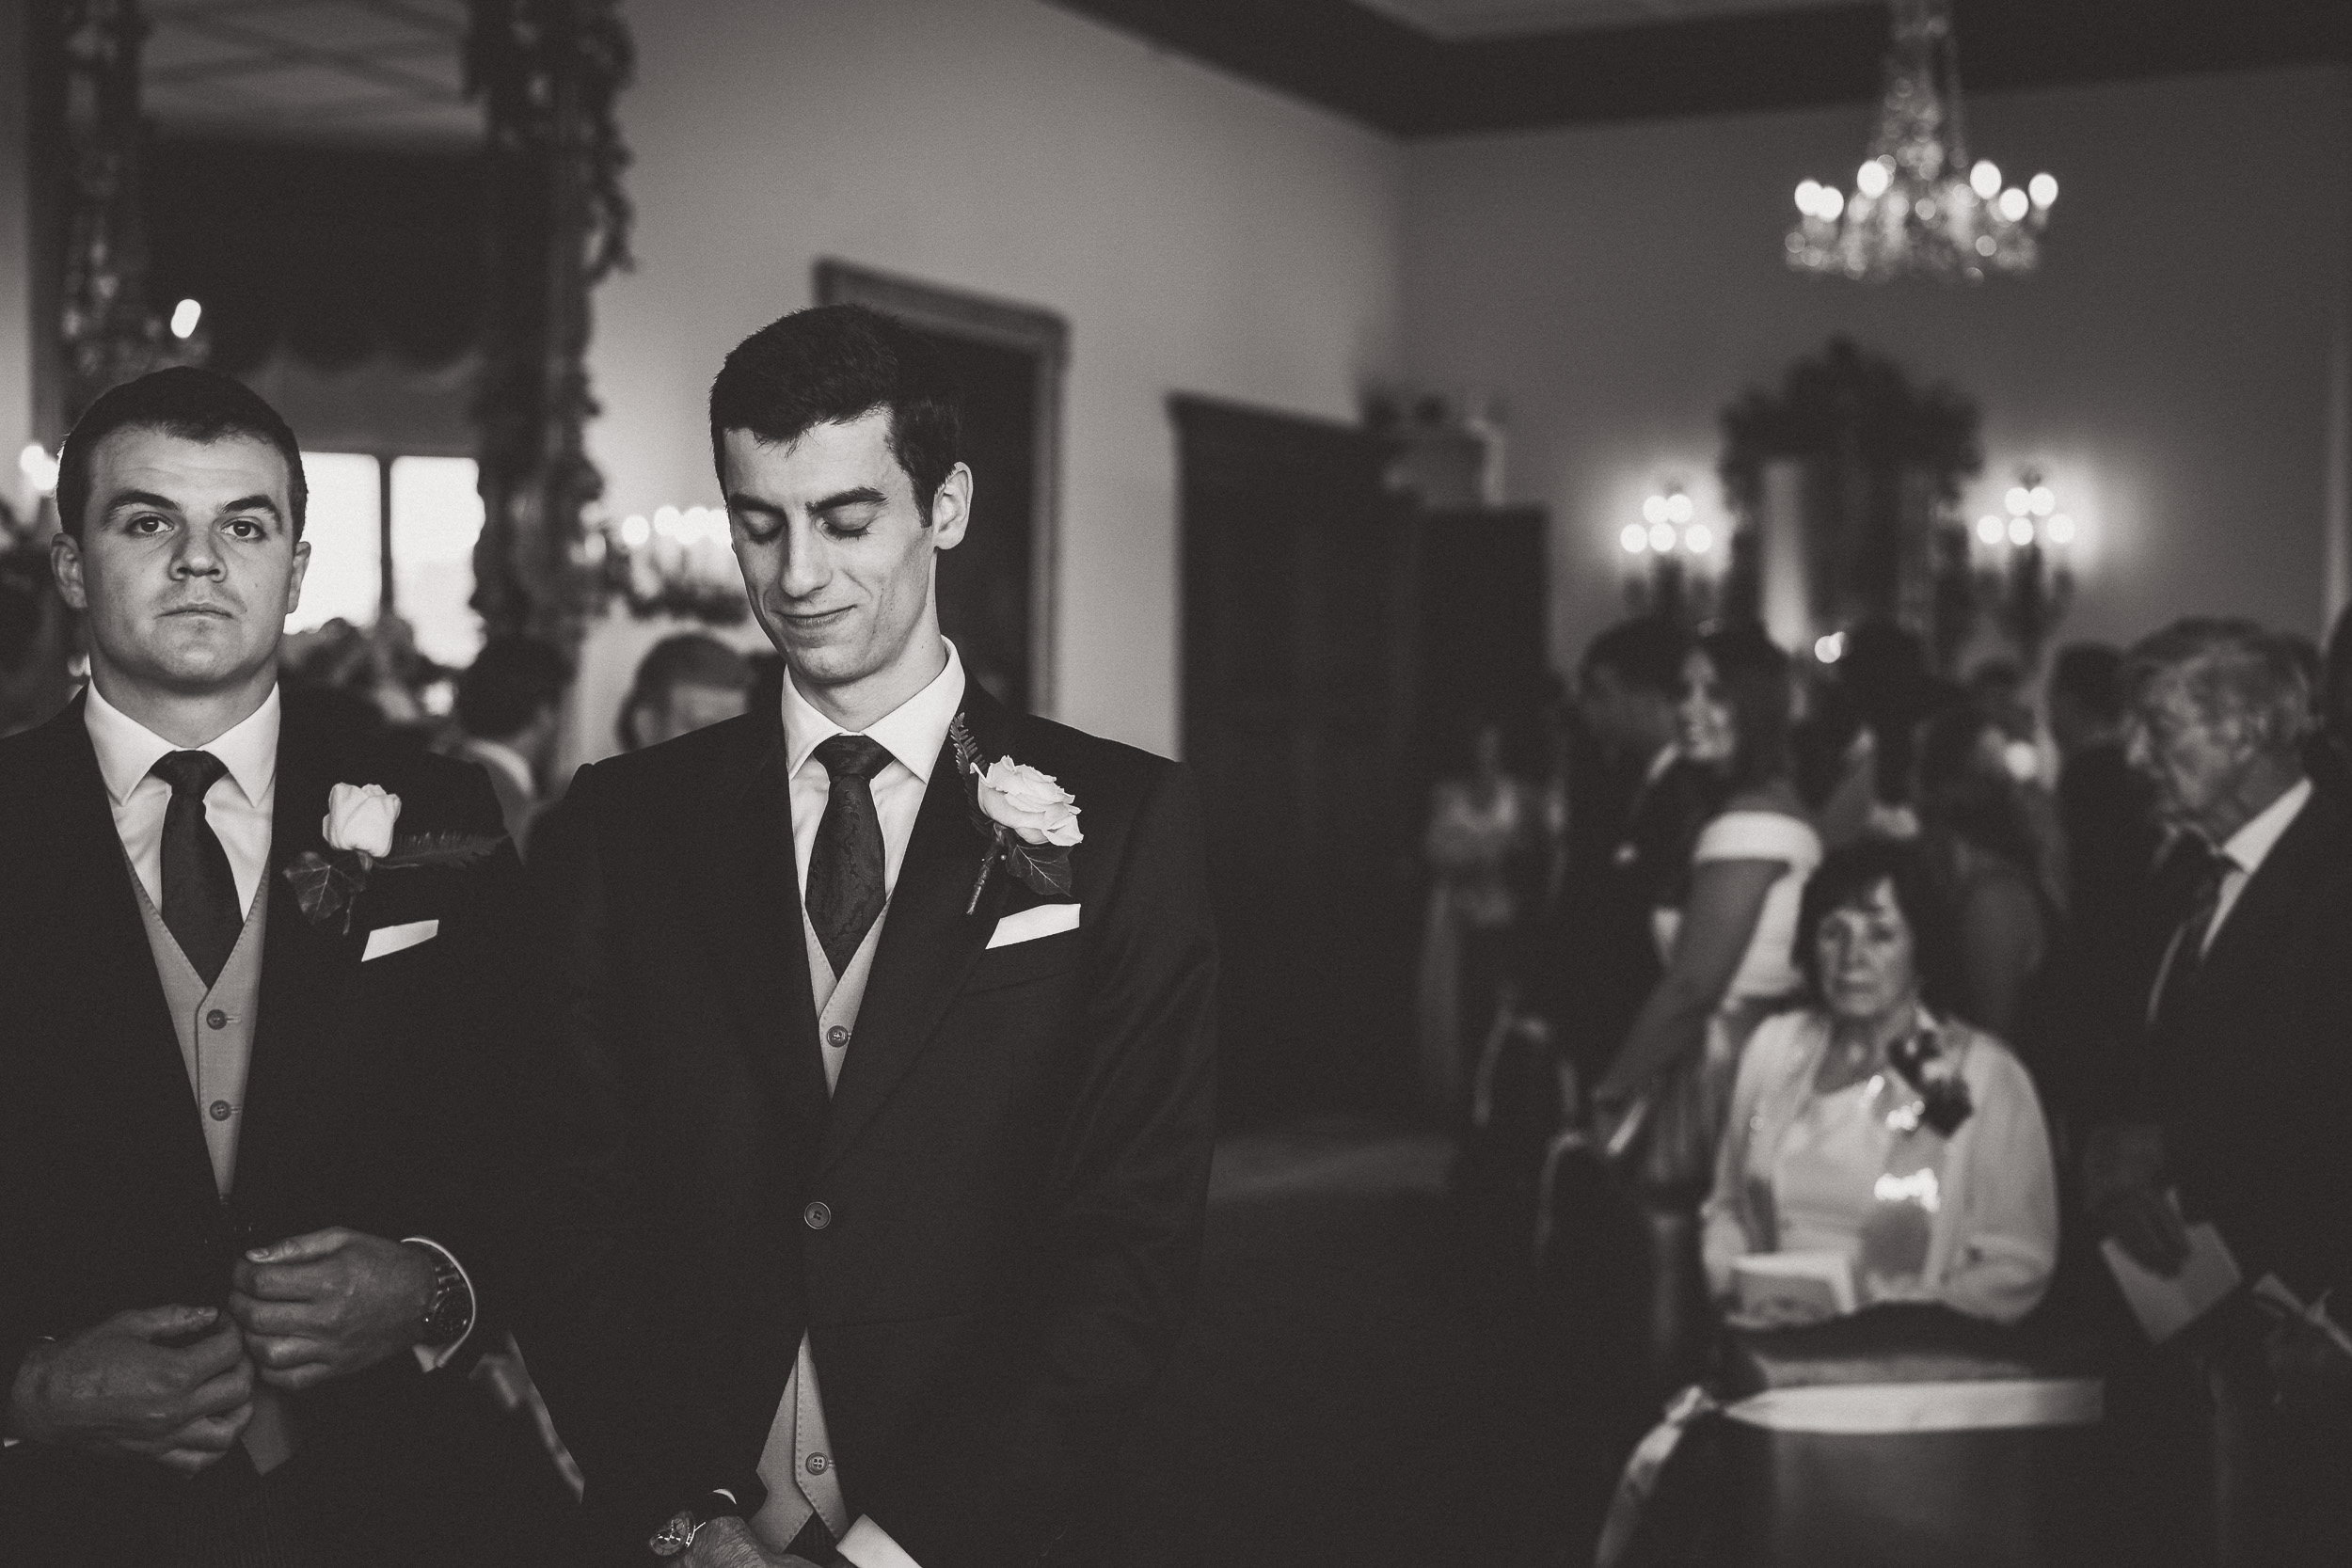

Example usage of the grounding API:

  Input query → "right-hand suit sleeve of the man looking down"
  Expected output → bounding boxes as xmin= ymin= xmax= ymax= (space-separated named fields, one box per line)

xmin=854 ymin=767 xmax=1216 ymax=1568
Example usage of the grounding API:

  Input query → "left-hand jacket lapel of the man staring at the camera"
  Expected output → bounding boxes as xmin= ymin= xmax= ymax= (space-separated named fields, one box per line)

xmin=32 ymin=698 xmax=215 ymax=1206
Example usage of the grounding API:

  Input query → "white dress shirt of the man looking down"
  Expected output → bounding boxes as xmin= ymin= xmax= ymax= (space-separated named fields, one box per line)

xmin=762 ymin=641 xmax=964 ymax=1568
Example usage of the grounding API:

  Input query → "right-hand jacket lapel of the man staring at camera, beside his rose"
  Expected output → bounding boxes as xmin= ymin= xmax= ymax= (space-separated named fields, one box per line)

xmin=235 ymin=715 xmax=374 ymax=1209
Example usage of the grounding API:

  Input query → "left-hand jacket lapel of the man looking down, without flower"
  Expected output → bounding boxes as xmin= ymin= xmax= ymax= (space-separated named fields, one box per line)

xmin=704 ymin=715 xmax=826 ymax=1129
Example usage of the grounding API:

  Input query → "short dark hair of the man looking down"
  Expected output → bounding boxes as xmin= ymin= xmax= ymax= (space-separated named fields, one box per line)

xmin=710 ymin=306 xmax=960 ymax=512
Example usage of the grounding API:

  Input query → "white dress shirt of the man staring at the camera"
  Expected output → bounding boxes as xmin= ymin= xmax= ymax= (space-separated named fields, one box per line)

xmin=83 ymin=682 xmax=473 ymax=1373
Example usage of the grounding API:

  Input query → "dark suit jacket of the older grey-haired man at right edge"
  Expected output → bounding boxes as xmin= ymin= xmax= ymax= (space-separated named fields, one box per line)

xmin=2126 ymin=790 xmax=2352 ymax=1300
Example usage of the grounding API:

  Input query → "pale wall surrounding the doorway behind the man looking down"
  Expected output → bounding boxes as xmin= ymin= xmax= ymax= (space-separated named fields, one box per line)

xmin=591 ymin=0 xmax=1402 ymax=752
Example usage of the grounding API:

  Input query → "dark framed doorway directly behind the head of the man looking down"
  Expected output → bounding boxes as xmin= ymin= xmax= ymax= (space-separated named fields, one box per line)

xmin=817 ymin=261 xmax=1068 ymax=712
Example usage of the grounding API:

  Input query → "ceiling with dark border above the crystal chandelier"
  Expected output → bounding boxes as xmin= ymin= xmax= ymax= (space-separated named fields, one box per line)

xmin=1049 ymin=0 xmax=2352 ymax=136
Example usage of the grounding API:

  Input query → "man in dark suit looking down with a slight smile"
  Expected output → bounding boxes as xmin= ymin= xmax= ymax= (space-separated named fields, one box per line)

xmin=522 ymin=306 xmax=1216 ymax=1568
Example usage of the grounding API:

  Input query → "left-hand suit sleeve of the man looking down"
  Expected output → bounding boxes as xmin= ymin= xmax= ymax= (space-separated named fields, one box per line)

xmin=513 ymin=767 xmax=765 ymax=1561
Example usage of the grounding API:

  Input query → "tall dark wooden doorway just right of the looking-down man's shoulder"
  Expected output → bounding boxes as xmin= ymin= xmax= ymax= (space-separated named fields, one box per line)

xmin=1174 ymin=397 xmax=1419 ymax=1124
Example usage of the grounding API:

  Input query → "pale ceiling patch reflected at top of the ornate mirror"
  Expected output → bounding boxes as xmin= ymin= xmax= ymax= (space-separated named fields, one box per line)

xmin=141 ymin=0 xmax=483 ymax=146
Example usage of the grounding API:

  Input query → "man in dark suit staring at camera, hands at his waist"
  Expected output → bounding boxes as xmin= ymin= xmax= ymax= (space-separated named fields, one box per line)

xmin=0 ymin=369 xmax=536 ymax=1566
